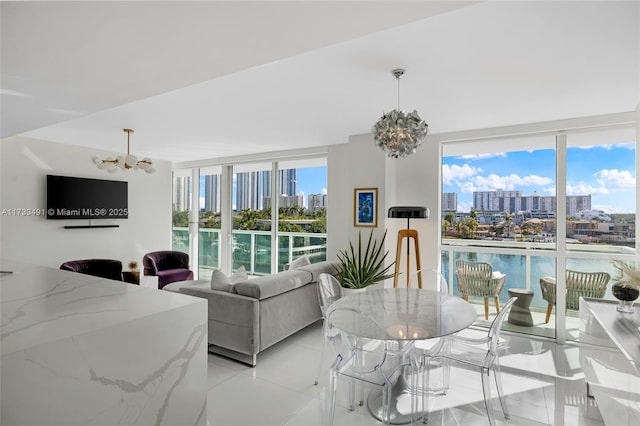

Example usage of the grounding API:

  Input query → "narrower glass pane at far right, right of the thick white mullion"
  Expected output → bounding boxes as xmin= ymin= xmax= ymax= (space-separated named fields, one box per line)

xmin=565 ymin=128 xmax=636 ymax=340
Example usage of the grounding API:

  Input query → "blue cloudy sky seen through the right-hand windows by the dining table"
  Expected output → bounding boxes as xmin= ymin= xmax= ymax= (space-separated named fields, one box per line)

xmin=442 ymin=143 xmax=636 ymax=213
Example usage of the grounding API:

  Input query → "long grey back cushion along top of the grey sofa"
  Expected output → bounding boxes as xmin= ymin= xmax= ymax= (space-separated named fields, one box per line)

xmin=231 ymin=269 xmax=313 ymax=300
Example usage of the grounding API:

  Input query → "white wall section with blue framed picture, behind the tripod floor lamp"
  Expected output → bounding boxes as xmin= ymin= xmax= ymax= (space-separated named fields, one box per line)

xmin=327 ymin=134 xmax=440 ymax=286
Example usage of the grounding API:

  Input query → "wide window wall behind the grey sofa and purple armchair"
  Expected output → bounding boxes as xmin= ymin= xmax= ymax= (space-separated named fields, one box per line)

xmin=172 ymin=154 xmax=328 ymax=278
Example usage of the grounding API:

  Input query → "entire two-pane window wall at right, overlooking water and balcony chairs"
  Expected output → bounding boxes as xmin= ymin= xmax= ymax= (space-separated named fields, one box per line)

xmin=441 ymin=116 xmax=636 ymax=340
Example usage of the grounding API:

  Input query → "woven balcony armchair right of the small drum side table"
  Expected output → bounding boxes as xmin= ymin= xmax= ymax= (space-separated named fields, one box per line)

xmin=540 ymin=269 xmax=611 ymax=323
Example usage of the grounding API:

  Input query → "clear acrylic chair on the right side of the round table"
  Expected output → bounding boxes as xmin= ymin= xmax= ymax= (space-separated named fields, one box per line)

xmin=421 ymin=297 xmax=517 ymax=425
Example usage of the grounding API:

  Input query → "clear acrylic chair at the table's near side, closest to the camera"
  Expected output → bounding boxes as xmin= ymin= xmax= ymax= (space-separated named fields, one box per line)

xmin=327 ymin=308 xmax=419 ymax=425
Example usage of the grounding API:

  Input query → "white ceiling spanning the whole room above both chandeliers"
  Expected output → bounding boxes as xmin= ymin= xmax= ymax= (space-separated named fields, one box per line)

xmin=0 ymin=1 xmax=640 ymax=162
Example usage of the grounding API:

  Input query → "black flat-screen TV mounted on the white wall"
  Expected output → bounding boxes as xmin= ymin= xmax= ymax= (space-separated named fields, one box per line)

xmin=47 ymin=175 xmax=129 ymax=219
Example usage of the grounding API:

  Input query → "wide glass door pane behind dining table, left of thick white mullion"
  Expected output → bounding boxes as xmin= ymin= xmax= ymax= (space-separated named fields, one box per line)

xmin=441 ymin=135 xmax=557 ymax=337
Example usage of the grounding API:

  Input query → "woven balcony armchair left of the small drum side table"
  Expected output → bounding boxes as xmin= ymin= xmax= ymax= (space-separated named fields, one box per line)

xmin=456 ymin=259 xmax=507 ymax=319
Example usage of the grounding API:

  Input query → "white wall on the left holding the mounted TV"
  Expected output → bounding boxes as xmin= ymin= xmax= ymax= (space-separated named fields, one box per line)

xmin=0 ymin=137 xmax=171 ymax=269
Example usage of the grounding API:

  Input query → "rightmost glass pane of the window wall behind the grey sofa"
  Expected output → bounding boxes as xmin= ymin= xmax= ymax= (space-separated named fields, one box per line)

xmin=278 ymin=158 xmax=328 ymax=271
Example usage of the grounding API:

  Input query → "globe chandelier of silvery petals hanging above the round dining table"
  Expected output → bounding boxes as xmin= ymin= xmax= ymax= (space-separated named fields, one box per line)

xmin=372 ymin=69 xmax=429 ymax=158
